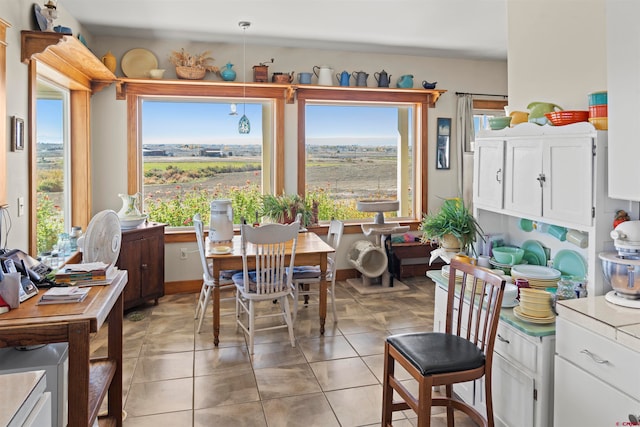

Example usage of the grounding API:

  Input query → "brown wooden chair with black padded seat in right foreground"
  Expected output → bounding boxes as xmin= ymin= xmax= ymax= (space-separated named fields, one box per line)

xmin=382 ymin=259 xmax=505 ymax=427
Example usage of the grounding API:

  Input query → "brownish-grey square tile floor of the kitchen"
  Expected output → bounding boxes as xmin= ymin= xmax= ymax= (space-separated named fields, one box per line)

xmin=92 ymin=277 xmax=475 ymax=427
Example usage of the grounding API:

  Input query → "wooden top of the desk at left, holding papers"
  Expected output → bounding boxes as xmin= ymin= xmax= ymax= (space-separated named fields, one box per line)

xmin=0 ymin=270 xmax=128 ymax=334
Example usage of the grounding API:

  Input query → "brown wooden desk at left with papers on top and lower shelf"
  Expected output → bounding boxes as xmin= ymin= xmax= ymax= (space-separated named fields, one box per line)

xmin=0 ymin=271 xmax=127 ymax=427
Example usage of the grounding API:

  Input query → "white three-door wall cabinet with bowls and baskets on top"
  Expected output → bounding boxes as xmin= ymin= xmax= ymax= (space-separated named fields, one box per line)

xmin=474 ymin=123 xmax=606 ymax=226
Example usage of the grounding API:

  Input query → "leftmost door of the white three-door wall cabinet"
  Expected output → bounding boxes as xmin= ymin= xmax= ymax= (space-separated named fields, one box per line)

xmin=473 ymin=139 xmax=504 ymax=209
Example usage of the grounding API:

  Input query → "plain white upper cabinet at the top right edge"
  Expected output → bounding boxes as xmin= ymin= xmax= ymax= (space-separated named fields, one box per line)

xmin=607 ymin=0 xmax=640 ymax=201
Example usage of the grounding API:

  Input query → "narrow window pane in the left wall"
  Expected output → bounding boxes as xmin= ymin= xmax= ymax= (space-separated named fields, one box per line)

xmin=36 ymin=81 xmax=71 ymax=254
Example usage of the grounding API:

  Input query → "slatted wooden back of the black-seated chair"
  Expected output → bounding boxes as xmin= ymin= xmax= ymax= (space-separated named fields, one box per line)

xmin=445 ymin=259 xmax=505 ymax=357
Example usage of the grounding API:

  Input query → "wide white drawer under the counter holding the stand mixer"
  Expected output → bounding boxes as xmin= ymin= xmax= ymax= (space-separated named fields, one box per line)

xmin=556 ymin=317 xmax=640 ymax=400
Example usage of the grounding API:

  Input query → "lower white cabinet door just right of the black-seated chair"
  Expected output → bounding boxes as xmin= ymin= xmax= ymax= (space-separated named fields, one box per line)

xmin=491 ymin=352 xmax=536 ymax=427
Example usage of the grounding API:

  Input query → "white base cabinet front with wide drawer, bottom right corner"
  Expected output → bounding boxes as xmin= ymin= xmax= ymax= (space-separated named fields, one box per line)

xmin=554 ymin=313 xmax=640 ymax=426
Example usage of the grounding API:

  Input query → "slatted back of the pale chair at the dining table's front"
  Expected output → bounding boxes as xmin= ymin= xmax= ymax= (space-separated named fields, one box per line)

xmin=240 ymin=222 xmax=300 ymax=294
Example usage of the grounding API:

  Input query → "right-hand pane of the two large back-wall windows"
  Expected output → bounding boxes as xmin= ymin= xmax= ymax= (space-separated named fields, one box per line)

xmin=305 ymin=104 xmax=415 ymax=220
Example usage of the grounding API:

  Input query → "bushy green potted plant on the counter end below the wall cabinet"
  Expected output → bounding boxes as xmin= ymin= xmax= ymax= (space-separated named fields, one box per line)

xmin=420 ymin=198 xmax=483 ymax=253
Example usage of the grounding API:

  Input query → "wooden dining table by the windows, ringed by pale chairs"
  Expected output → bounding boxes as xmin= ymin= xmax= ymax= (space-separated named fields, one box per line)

xmin=205 ymin=232 xmax=334 ymax=346
